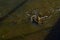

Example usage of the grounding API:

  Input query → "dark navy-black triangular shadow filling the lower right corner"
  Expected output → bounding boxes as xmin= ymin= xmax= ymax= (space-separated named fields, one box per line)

xmin=45 ymin=18 xmax=60 ymax=40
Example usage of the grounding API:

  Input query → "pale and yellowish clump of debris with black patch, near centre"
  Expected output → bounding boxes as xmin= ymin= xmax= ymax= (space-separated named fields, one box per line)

xmin=26 ymin=10 xmax=48 ymax=24
